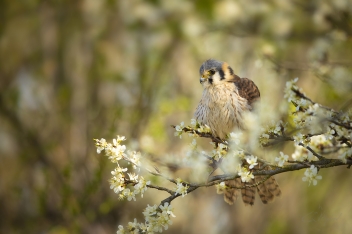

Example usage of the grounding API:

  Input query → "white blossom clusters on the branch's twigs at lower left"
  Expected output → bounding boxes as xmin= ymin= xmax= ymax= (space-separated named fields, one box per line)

xmin=94 ymin=136 xmax=179 ymax=233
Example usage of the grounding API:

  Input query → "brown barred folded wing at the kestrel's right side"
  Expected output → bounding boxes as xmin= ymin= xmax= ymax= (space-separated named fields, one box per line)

xmin=234 ymin=78 xmax=260 ymax=106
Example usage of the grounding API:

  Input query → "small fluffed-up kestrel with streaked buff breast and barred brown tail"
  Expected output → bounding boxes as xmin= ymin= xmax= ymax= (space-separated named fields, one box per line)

xmin=194 ymin=59 xmax=281 ymax=205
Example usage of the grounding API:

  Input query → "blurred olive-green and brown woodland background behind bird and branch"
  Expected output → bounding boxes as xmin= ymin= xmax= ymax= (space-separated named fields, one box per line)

xmin=0 ymin=0 xmax=352 ymax=234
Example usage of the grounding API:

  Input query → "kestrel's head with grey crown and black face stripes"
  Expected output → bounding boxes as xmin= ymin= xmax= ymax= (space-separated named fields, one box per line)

xmin=199 ymin=59 xmax=235 ymax=88
